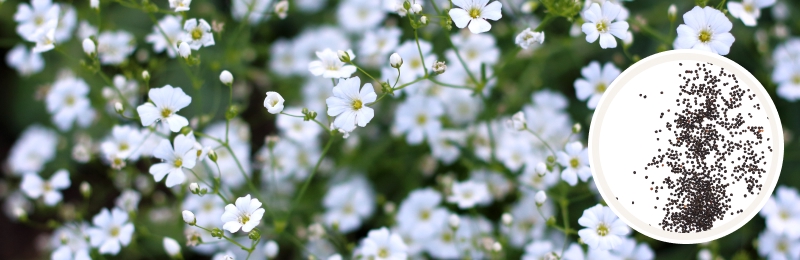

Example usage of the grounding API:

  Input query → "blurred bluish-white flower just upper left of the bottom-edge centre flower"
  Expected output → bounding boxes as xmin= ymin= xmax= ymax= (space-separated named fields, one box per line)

xmin=322 ymin=178 xmax=375 ymax=233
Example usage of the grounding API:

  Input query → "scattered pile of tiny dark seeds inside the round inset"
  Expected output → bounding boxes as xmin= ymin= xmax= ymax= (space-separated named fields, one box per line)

xmin=634 ymin=63 xmax=772 ymax=233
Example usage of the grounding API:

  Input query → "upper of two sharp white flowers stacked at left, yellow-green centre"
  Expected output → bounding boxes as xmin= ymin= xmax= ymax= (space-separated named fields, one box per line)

xmin=136 ymin=85 xmax=192 ymax=132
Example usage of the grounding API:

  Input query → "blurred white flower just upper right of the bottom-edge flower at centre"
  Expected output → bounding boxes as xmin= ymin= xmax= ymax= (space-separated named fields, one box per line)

xmin=397 ymin=188 xmax=448 ymax=241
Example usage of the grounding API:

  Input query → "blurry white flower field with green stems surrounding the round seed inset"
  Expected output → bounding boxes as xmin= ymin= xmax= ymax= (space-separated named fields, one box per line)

xmin=0 ymin=0 xmax=800 ymax=259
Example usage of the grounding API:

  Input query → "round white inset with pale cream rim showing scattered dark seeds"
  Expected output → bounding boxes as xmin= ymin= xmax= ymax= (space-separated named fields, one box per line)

xmin=589 ymin=50 xmax=784 ymax=244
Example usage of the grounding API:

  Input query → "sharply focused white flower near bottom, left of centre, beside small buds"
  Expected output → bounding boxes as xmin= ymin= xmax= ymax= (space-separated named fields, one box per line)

xmin=221 ymin=194 xmax=264 ymax=233
